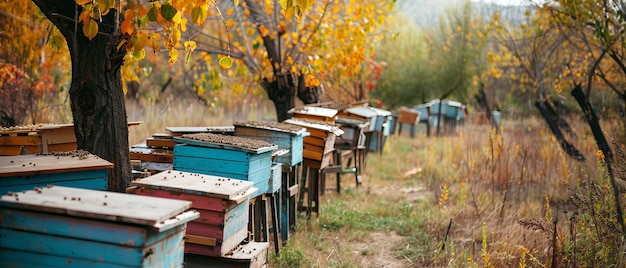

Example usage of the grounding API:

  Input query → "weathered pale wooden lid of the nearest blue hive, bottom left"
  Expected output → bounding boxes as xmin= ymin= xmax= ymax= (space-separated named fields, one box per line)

xmin=0 ymin=186 xmax=191 ymax=226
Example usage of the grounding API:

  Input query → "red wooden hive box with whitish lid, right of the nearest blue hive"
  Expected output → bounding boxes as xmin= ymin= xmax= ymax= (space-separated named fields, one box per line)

xmin=131 ymin=170 xmax=256 ymax=257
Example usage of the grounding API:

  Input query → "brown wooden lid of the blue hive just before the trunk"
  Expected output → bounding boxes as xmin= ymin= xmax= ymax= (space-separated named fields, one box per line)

xmin=0 ymin=154 xmax=113 ymax=177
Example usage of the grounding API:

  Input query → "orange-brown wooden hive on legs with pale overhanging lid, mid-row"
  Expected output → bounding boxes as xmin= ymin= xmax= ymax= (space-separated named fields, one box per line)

xmin=284 ymin=119 xmax=344 ymax=169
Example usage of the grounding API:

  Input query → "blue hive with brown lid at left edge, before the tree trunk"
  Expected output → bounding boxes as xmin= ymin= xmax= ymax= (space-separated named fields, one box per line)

xmin=0 ymin=151 xmax=113 ymax=194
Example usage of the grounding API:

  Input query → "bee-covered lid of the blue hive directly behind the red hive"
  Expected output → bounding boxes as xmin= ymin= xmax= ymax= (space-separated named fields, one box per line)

xmin=174 ymin=133 xmax=278 ymax=154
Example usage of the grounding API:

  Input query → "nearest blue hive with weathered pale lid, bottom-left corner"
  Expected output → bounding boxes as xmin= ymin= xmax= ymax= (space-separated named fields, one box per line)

xmin=0 ymin=186 xmax=199 ymax=267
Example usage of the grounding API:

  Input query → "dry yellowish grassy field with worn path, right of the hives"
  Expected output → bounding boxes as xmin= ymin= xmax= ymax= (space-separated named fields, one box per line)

xmin=272 ymin=119 xmax=624 ymax=267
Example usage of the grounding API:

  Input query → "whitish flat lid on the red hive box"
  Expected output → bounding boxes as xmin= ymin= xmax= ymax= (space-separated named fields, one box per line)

xmin=130 ymin=170 xmax=257 ymax=203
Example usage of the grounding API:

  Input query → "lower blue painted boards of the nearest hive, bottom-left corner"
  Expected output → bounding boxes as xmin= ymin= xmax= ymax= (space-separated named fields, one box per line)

xmin=0 ymin=225 xmax=186 ymax=267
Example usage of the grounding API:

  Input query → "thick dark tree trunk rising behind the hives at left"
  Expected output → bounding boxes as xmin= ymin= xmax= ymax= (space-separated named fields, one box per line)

xmin=33 ymin=0 xmax=131 ymax=192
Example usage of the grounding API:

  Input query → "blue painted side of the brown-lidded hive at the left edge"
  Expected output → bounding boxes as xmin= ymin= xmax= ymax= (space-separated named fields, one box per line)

xmin=0 ymin=169 xmax=108 ymax=194
